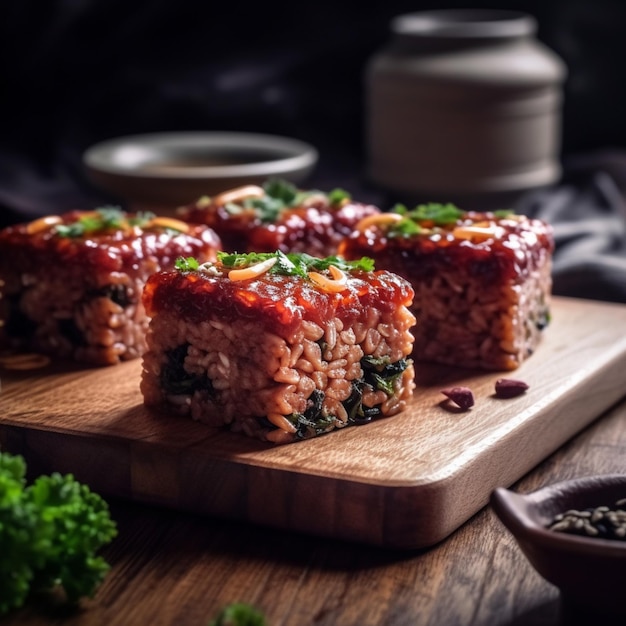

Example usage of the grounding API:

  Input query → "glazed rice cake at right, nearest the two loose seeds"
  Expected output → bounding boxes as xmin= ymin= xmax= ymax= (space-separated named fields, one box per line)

xmin=340 ymin=204 xmax=554 ymax=370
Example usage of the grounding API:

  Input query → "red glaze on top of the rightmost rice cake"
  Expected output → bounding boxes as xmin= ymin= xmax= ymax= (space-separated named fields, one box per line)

xmin=339 ymin=212 xmax=554 ymax=283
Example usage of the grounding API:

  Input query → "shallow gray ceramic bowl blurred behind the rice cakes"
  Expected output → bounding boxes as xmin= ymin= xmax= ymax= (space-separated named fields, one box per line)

xmin=83 ymin=131 xmax=318 ymax=210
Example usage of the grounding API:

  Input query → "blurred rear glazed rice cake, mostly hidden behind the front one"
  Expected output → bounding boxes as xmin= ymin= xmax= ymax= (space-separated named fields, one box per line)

xmin=177 ymin=179 xmax=380 ymax=257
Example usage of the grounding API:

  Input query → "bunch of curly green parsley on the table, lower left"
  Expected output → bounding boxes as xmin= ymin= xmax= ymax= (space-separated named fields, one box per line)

xmin=0 ymin=452 xmax=117 ymax=615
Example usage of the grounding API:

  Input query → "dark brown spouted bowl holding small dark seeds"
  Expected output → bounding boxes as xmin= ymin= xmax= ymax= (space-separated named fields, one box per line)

xmin=491 ymin=474 xmax=626 ymax=623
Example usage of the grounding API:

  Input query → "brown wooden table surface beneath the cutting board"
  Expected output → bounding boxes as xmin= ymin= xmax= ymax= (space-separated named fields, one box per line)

xmin=0 ymin=382 xmax=626 ymax=626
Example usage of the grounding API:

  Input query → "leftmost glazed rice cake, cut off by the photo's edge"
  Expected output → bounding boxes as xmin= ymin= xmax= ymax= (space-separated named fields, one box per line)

xmin=0 ymin=207 xmax=221 ymax=365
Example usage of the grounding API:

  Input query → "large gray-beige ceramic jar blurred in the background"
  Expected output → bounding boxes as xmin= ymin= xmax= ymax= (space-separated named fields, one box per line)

xmin=365 ymin=10 xmax=566 ymax=209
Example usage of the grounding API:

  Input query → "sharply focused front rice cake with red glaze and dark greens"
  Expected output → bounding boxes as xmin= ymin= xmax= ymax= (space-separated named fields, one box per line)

xmin=141 ymin=251 xmax=415 ymax=444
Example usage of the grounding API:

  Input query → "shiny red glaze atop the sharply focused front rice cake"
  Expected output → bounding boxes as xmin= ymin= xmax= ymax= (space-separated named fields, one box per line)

xmin=143 ymin=271 xmax=414 ymax=338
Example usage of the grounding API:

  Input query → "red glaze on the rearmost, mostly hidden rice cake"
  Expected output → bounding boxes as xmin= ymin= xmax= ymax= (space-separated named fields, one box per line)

xmin=179 ymin=199 xmax=380 ymax=257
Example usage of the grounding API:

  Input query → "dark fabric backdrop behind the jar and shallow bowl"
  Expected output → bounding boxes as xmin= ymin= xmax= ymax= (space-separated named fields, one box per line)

xmin=0 ymin=0 xmax=626 ymax=302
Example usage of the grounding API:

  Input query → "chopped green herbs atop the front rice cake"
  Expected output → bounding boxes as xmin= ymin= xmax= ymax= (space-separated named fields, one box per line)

xmin=217 ymin=250 xmax=374 ymax=278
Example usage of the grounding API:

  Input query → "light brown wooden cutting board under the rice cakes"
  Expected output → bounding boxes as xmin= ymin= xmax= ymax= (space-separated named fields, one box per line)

xmin=0 ymin=298 xmax=626 ymax=548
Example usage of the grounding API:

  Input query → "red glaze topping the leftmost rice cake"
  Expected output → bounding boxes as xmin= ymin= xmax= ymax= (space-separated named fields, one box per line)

xmin=0 ymin=211 xmax=221 ymax=274
